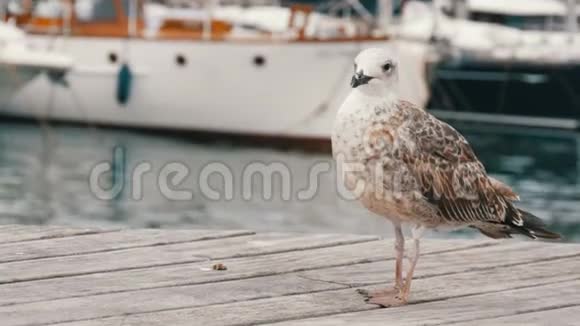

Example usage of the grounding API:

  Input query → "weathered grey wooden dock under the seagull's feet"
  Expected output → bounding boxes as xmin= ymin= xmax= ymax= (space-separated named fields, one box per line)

xmin=0 ymin=226 xmax=580 ymax=326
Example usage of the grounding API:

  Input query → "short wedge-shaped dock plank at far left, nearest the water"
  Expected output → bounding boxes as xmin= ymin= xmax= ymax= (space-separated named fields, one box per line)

xmin=0 ymin=225 xmax=118 ymax=243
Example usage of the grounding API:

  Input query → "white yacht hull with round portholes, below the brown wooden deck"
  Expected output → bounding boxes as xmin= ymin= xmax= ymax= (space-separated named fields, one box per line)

xmin=2 ymin=36 xmax=426 ymax=138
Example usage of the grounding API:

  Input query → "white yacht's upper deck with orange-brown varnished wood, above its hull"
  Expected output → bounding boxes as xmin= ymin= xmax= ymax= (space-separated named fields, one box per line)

xmin=5 ymin=0 xmax=385 ymax=41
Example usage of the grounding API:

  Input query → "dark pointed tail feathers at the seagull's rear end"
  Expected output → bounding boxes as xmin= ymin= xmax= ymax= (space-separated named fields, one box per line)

xmin=472 ymin=207 xmax=562 ymax=240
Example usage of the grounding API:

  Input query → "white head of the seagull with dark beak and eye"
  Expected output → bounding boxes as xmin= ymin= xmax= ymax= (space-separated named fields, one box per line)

xmin=350 ymin=48 xmax=398 ymax=91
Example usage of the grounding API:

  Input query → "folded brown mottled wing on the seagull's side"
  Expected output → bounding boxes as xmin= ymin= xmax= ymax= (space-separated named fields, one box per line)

xmin=397 ymin=102 xmax=522 ymax=225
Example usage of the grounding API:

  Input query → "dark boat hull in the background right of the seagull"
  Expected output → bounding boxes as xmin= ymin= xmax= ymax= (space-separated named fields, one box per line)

xmin=427 ymin=60 xmax=580 ymax=129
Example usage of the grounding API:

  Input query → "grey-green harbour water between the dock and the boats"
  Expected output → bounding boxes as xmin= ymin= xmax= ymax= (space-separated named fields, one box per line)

xmin=0 ymin=123 xmax=580 ymax=241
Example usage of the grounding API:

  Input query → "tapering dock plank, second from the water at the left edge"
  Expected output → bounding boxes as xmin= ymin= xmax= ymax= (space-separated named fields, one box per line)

xmin=0 ymin=229 xmax=255 ymax=263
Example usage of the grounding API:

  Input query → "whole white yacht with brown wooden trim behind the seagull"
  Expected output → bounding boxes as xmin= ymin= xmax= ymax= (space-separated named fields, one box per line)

xmin=3 ymin=0 xmax=427 ymax=139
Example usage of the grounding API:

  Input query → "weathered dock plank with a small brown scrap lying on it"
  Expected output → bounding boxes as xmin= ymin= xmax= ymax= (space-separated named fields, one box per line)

xmin=0 ymin=240 xmax=490 ymax=306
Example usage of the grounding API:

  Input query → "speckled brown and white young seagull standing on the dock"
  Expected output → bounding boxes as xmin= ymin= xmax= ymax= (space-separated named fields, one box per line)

xmin=332 ymin=48 xmax=560 ymax=307
